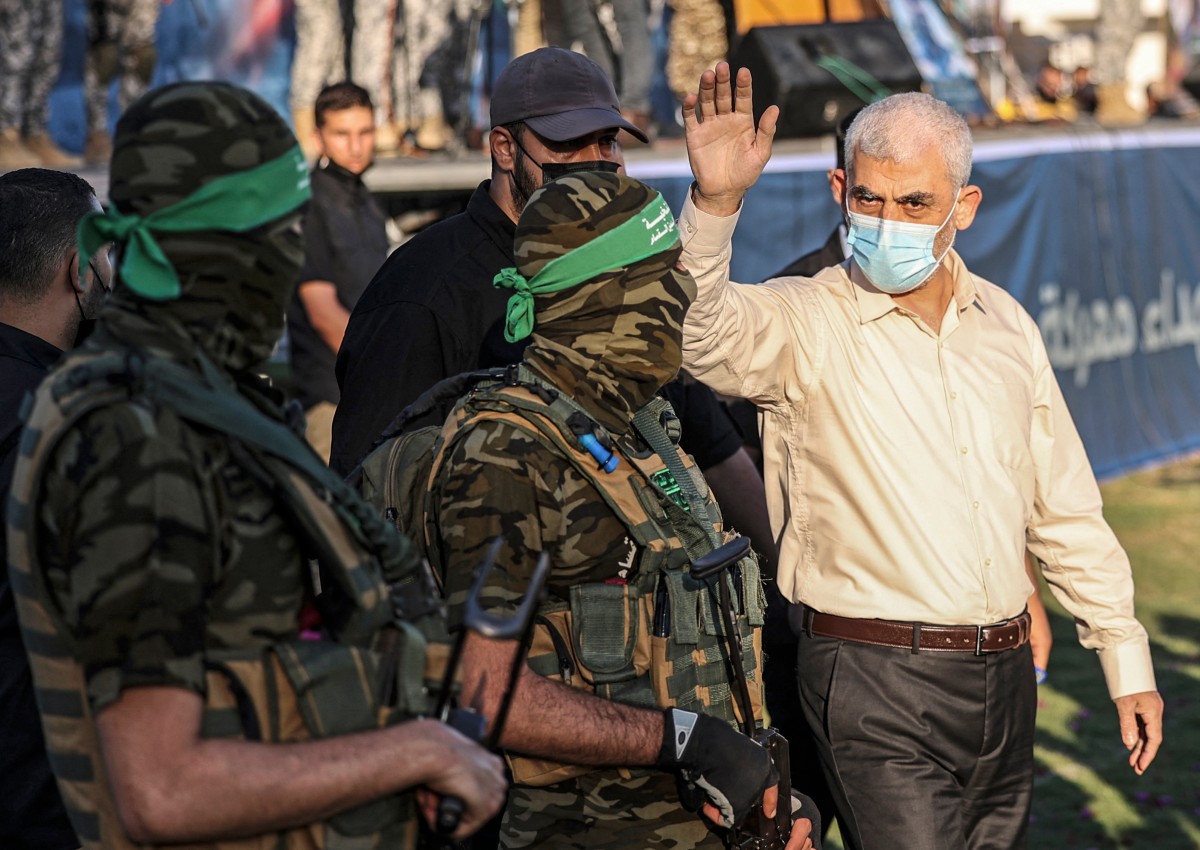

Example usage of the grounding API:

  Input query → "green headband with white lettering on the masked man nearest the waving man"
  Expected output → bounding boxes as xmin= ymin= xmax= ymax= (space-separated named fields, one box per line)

xmin=492 ymin=194 xmax=679 ymax=342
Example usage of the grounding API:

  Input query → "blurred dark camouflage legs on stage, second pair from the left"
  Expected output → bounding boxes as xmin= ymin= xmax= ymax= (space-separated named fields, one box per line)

xmin=83 ymin=0 xmax=163 ymax=166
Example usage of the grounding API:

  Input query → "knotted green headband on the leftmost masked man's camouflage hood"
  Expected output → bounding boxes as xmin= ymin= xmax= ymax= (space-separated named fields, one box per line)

xmin=76 ymin=148 xmax=312 ymax=301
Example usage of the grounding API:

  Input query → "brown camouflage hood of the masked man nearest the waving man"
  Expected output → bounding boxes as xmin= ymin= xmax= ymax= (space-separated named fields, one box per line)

xmin=515 ymin=172 xmax=696 ymax=433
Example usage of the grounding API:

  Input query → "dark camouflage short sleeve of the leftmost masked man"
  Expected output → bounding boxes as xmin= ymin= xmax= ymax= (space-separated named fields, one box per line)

xmin=37 ymin=405 xmax=216 ymax=711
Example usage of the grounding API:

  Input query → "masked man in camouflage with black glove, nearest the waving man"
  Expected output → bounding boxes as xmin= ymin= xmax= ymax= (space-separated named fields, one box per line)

xmin=430 ymin=172 xmax=811 ymax=850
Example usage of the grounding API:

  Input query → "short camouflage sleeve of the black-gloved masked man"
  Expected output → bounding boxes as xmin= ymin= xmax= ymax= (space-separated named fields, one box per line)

xmin=434 ymin=421 xmax=632 ymax=622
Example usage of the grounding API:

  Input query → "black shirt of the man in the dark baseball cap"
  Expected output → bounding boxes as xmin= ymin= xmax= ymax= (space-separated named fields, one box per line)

xmin=329 ymin=180 xmax=742 ymax=475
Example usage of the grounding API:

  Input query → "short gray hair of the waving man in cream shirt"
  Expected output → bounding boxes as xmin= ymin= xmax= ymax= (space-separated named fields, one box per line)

xmin=846 ymin=91 xmax=971 ymax=188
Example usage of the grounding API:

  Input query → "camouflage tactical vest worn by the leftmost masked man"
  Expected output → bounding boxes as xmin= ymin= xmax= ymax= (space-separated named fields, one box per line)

xmin=8 ymin=352 xmax=445 ymax=850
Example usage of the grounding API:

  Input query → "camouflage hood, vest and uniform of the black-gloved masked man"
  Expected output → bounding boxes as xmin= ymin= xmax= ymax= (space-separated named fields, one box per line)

xmin=431 ymin=173 xmax=762 ymax=849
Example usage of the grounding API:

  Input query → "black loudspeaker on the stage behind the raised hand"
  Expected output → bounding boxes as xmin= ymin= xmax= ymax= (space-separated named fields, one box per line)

xmin=731 ymin=18 xmax=922 ymax=137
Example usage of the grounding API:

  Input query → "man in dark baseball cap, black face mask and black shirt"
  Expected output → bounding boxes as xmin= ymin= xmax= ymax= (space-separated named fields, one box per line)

xmin=330 ymin=47 xmax=646 ymax=474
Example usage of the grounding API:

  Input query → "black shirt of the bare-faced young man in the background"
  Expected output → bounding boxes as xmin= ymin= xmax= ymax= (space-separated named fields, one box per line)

xmin=288 ymin=160 xmax=388 ymax=409
